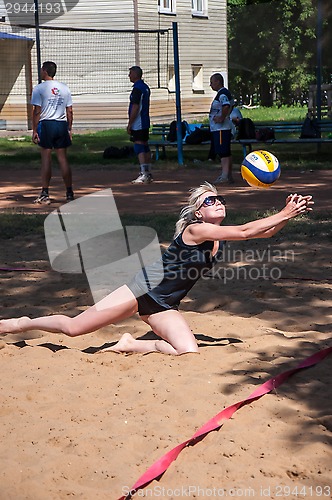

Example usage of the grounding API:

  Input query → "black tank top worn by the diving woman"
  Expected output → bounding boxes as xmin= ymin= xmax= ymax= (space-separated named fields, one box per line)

xmin=128 ymin=228 xmax=224 ymax=309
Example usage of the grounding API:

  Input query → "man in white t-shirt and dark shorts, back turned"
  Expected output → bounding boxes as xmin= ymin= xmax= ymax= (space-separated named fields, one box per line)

xmin=31 ymin=61 xmax=74 ymax=205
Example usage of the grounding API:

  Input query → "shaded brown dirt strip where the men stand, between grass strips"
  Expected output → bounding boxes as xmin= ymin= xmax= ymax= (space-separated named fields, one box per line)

xmin=0 ymin=166 xmax=332 ymax=214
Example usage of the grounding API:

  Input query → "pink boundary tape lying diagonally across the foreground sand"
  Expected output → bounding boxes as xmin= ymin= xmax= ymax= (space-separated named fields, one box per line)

xmin=118 ymin=347 xmax=332 ymax=500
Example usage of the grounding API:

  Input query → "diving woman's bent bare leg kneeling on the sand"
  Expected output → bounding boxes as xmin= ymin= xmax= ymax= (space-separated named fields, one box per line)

xmin=100 ymin=310 xmax=198 ymax=355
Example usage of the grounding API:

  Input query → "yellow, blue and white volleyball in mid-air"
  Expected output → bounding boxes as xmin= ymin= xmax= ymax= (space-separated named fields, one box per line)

xmin=241 ymin=150 xmax=280 ymax=188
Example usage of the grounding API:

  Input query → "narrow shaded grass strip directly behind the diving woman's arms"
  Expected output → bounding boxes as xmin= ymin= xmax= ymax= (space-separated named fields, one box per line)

xmin=0 ymin=211 xmax=332 ymax=242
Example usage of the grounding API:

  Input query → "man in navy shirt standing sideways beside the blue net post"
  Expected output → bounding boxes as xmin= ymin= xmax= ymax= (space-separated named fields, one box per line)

xmin=127 ymin=66 xmax=153 ymax=184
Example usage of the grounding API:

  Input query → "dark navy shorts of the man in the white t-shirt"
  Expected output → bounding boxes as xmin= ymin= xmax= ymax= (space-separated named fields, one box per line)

xmin=38 ymin=120 xmax=71 ymax=149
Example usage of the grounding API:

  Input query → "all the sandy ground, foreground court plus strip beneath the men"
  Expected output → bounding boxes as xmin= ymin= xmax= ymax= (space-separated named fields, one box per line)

xmin=0 ymin=169 xmax=332 ymax=500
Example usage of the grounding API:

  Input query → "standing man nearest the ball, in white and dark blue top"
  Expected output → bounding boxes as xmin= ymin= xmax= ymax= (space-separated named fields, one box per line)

xmin=209 ymin=73 xmax=234 ymax=184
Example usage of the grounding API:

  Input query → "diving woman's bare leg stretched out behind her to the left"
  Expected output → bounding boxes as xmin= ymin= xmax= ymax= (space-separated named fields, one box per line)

xmin=0 ymin=285 xmax=137 ymax=337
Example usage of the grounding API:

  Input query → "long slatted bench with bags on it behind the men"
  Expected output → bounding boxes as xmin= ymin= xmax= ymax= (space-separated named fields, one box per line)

xmin=149 ymin=120 xmax=332 ymax=161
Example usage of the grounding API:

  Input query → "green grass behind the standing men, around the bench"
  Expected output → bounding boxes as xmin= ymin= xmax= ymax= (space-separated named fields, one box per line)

xmin=0 ymin=106 xmax=332 ymax=170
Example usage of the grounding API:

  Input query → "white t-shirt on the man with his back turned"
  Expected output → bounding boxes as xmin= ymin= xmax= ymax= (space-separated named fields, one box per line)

xmin=31 ymin=80 xmax=73 ymax=121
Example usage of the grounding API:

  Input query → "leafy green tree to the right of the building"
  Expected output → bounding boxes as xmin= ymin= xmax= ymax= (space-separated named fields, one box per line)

xmin=228 ymin=0 xmax=332 ymax=106
